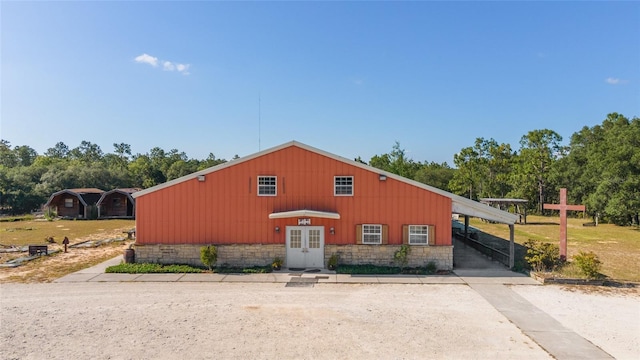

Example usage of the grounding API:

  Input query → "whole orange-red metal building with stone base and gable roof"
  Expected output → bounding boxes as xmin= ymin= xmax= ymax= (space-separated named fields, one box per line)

xmin=132 ymin=141 xmax=517 ymax=269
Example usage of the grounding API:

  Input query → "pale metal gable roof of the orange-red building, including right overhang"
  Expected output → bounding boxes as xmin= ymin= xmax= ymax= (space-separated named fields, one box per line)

xmin=132 ymin=141 xmax=518 ymax=224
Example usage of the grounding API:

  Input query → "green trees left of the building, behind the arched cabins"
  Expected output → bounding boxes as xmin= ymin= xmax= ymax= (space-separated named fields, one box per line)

xmin=0 ymin=140 xmax=230 ymax=214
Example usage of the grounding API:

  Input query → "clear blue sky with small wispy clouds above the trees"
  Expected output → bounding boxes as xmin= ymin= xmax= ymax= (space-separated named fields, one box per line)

xmin=0 ymin=1 xmax=640 ymax=165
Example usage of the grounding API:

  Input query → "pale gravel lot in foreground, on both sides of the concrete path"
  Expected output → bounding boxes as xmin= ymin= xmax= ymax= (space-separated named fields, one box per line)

xmin=0 ymin=283 xmax=640 ymax=359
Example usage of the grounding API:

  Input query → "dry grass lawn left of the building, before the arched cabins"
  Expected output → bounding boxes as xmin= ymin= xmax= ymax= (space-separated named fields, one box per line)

xmin=0 ymin=220 xmax=135 ymax=246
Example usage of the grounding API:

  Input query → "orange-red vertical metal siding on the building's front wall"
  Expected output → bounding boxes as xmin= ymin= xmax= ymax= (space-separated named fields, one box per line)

xmin=136 ymin=146 xmax=451 ymax=245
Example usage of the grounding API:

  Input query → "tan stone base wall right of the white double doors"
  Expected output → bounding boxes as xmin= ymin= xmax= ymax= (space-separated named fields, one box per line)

xmin=324 ymin=245 xmax=453 ymax=270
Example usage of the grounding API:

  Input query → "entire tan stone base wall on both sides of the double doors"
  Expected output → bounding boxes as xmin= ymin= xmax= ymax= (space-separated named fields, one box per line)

xmin=134 ymin=244 xmax=453 ymax=270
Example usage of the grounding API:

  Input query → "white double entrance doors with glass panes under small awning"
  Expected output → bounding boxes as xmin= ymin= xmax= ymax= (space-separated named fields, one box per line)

xmin=287 ymin=226 xmax=324 ymax=268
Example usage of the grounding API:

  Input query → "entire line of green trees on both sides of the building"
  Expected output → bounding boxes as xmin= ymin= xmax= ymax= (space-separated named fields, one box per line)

xmin=0 ymin=113 xmax=640 ymax=225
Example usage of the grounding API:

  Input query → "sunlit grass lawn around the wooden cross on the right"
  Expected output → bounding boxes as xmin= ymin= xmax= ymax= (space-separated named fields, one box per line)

xmin=469 ymin=215 xmax=640 ymax=282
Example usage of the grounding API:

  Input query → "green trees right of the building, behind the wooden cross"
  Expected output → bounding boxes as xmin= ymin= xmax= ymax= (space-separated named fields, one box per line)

xmin=368 ymin=113 xmax=640 ymax=225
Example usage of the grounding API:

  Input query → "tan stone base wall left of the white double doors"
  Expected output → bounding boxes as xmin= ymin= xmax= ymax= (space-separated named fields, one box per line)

xmin=134 ymin=244 xmax=286 ymax=266
